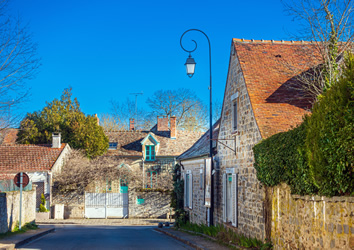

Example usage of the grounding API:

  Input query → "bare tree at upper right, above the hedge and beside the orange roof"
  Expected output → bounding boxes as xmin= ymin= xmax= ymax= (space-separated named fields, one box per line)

xmin=284 ymin=0 xmax=354 ymax=97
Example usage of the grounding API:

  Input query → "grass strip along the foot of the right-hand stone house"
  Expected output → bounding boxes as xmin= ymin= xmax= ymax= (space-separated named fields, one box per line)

xmin=180 ymin=222 xmax=272 ymax=250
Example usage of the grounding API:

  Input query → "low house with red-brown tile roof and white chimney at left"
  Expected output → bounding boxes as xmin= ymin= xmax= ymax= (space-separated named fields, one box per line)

xmin=0 ymin=133 xmax=70 ymax=209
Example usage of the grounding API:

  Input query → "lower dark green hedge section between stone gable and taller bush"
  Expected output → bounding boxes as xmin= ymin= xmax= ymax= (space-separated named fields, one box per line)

xmin=253 ymin=122 xmax=317 ymax=195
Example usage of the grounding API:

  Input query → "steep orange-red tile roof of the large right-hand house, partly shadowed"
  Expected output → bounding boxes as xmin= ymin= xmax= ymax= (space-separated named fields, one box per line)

xmin=233 ymin=39 xmax=321 ymax=138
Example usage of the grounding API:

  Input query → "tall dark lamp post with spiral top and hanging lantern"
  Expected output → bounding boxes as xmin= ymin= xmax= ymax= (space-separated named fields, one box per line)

xmin=180 ymin=29 xmax=214 ymax=225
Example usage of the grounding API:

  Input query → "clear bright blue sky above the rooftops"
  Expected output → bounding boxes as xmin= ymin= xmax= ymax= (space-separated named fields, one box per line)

xmin=10 ymin=0 xmax=297 ymax=118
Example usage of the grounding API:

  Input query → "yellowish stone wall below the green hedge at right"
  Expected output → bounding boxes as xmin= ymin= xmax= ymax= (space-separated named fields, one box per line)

xmin=269 ymin=184 xmax=354 ymax=249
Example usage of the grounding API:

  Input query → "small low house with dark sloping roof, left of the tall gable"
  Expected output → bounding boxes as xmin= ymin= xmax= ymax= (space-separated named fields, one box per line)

xmin=177 ymin=119 xmax=220 ymax=225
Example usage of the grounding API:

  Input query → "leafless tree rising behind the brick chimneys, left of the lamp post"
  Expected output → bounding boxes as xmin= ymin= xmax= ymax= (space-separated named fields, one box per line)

xmin=147 ymin=89 xmax=208 ymax=131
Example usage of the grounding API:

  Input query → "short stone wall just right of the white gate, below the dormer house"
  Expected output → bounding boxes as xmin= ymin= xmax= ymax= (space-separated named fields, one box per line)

xmin=129 ymin=190 xmax=171 ymax=218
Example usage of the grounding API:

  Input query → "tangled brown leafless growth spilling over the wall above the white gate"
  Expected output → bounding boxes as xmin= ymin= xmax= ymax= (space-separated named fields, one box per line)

xmin=54 ymin=150 xmax=172 ymax=197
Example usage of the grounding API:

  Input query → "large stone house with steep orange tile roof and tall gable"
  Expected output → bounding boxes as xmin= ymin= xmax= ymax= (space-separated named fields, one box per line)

xmin=181 ymin=39 xmax=320 ymax=240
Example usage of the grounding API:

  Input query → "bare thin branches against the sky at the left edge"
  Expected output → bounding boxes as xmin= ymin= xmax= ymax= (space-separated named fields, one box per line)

xmin=0 ymin=0 xmax=39 ymax=129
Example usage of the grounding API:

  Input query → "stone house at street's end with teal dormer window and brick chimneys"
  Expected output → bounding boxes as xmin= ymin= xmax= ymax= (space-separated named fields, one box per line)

xmin=76 ymin=116 xmax=202 ymax=218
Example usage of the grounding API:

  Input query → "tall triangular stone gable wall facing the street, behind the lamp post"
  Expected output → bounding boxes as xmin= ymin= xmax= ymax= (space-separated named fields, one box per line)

xmin=214 ymin=46 xmax=265 ymax=240
